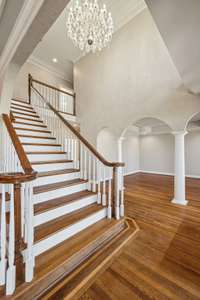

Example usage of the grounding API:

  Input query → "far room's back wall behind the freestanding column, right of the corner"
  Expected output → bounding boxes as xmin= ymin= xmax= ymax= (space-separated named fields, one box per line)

xmin=140 ymin=131 xmax=200 ymax=177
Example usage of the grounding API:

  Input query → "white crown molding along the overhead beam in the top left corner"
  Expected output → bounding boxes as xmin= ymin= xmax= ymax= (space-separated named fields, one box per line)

xmin=0 ymin=0 xmax=44 ymax=77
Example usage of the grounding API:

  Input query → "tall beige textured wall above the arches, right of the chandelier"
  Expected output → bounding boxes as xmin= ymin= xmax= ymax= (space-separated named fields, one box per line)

xmin=74 ymin=9 xmax=200 ymax=144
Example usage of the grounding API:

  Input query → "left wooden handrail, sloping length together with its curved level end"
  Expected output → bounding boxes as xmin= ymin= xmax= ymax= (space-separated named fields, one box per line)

xmin=0 ymin=114 xmax=37 ymax=183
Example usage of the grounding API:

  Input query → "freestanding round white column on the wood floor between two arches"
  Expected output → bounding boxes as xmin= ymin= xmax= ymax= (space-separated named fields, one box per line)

xmin=172 ymin=131 xmax=188 ymax=205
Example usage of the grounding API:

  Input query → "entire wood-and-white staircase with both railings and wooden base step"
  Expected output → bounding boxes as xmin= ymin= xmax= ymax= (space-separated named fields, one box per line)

xmin=0 ymin=77 xmax=137 ymax=300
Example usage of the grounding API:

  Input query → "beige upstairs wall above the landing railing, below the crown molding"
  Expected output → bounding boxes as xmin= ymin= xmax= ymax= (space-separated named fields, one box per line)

xmin=14 ymin=62 xmax=72 ymax=101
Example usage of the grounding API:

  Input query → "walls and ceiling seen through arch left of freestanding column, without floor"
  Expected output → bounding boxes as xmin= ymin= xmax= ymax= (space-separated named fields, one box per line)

xmin=122 ymin=118 xmax=174 ymax=175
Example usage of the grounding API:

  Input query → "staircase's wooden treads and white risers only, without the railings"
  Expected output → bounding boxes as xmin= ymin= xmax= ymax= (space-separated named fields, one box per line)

xmin=11 ymin=100 xmax=107 ymax=257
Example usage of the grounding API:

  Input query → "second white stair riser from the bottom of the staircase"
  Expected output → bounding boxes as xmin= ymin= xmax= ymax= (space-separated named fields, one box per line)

xmin=34 ymin=195 xmax=97 ymax=227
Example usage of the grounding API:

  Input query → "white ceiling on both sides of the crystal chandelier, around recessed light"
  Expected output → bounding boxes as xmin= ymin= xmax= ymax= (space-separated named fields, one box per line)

xmin=32 ymin=0 xmax=146 ymax=79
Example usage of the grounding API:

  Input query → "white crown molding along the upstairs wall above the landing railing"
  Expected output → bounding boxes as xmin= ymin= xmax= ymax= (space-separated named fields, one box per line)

xmin=27 ymin=55 xmax=72 ymax=85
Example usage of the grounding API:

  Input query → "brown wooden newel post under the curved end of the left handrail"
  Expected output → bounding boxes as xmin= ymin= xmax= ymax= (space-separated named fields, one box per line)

xmin=14 ymin=183 xmax=25 ymax=281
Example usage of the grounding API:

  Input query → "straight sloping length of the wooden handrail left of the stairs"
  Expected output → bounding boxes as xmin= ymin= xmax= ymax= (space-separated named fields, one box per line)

xmin=1 ymin=114 xmax=37 ymax=178
